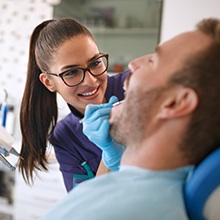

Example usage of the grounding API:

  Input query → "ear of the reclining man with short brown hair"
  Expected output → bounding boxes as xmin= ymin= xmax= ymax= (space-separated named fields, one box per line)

xmin=158 ymin=87 xmax=198 ymax=119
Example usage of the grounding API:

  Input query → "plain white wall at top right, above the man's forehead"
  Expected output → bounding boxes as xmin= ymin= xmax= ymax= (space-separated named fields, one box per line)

xmin=161 ymin=0 xmax=220 ymax=41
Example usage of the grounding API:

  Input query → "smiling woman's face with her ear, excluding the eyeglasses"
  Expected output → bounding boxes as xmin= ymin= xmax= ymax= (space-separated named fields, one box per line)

xmin=40 ymin=35 xmax=107 ymax=114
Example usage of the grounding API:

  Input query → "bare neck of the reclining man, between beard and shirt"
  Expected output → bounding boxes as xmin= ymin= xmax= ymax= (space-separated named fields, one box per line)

xmin=121 ymin=120 xmax=189 ymax=170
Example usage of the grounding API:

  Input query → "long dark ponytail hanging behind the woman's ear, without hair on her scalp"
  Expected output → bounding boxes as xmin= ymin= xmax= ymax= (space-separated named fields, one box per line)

xmin=19 ymin=20 xmax=57 ymax=184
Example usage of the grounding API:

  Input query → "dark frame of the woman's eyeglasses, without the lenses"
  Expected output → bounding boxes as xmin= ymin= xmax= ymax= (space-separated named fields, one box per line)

xmin=43 ymin=53 xmax=109 ymax=87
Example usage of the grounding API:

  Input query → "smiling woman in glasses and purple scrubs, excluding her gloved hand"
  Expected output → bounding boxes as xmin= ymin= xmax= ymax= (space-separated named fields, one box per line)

xmin=19 ymin=18 xmax=129 ymax=191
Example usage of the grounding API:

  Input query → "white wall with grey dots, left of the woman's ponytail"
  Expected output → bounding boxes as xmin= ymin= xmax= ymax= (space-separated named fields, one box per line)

xmin=0 ymin=0 xmax=57 ymax=139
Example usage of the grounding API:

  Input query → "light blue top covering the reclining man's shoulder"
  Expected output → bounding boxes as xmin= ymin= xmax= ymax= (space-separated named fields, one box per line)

xmin=43 ymin=171 xmax=187 ymax=220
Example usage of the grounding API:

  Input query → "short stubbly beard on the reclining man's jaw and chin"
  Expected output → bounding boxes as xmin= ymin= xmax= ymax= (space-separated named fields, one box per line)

xmin=110 ymin=87 xmax=165 ymax=146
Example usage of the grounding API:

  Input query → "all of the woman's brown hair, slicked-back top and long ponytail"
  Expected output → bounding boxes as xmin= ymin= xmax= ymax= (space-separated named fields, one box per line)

xmin=18 ymin=18 xmax=94 ymax=184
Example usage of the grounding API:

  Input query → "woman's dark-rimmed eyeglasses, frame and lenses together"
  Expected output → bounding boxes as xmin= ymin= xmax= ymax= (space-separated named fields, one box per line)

xmin=44 ymin=53 xmax=109 ymax=87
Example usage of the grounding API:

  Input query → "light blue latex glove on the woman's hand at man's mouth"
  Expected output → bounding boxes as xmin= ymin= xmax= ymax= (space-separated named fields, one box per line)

xmin=83 ymin=96 xmax=125 ymax=170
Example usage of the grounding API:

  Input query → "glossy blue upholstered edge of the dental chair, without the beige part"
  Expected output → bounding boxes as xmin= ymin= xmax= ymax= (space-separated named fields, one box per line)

xmin=184 ymin=148 xmax=220 ymax=220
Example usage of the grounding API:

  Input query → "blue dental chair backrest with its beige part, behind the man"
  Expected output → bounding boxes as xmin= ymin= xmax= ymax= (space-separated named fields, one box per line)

xmin=184 ymin=148 xmax=220 ymax=220
